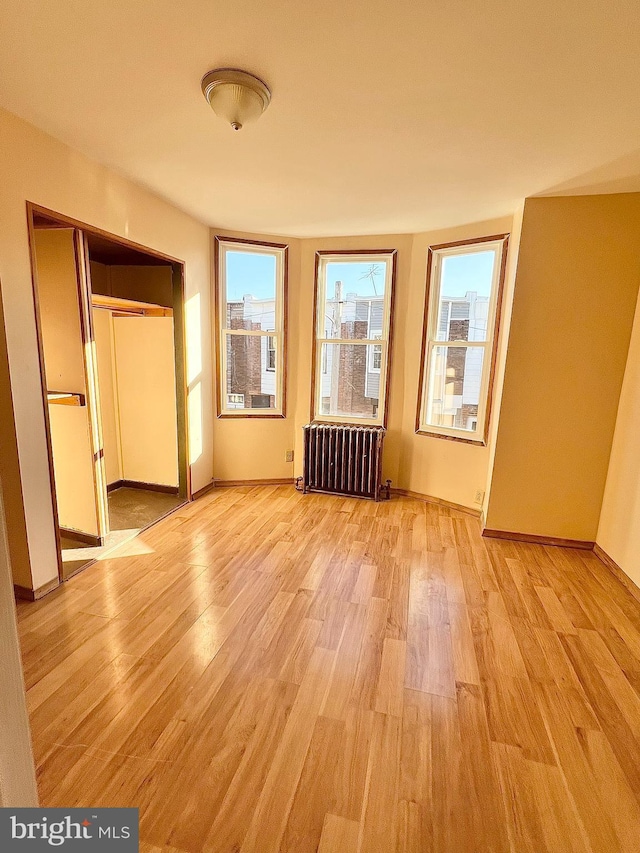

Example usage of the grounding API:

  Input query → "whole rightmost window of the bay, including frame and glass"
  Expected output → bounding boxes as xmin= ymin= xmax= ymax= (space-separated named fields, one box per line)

xmin=416 ymin=234 xmax=509 ymax=444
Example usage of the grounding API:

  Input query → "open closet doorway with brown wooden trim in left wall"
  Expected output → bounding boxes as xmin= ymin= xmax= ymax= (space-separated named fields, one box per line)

xmin=27 ymin=204 xmax=191 ymax=580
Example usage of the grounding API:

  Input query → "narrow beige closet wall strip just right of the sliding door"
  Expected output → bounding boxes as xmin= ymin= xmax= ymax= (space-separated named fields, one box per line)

xmin=92 ymin=308 xmax=122 ymax=485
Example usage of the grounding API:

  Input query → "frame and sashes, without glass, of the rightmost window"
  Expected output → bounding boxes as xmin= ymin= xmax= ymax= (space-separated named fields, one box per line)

xmin=416 ymin=234 xmax=509 ymax=445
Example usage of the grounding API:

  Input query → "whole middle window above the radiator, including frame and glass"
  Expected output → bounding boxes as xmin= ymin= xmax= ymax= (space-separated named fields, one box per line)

xmin=313 ymin=250 xmax=396 ymax=424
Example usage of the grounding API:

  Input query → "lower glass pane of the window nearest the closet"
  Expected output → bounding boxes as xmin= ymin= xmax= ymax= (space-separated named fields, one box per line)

xmin=225 ymin=335 xmax=278 ymax=409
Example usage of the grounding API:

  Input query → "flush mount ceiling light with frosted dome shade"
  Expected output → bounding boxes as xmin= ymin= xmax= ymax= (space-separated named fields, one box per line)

xmin=202 ymin=68 xmax=271 ymax=130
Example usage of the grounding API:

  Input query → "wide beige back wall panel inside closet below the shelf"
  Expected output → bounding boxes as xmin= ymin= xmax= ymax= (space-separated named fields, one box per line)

xmin=113 ymin=317 xmax=178 ymax=486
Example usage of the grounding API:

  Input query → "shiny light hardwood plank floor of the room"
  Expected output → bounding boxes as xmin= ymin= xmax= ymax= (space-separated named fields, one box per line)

xmin=13 ymin=486 xmax=640 ymax=853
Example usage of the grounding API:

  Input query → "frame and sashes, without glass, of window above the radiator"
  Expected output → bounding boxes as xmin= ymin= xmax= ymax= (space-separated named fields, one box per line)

xmin=313 ymin=249 xmax=397 ymax=426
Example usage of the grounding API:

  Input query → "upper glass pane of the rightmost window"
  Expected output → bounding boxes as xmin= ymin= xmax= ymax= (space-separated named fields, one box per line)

xmin=436 ymin=250 xmax=496 ymax=341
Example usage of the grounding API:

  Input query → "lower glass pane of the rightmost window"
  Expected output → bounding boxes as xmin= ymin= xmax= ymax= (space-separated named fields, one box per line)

xmin=426 ymin=346 xmax=484 ymax=432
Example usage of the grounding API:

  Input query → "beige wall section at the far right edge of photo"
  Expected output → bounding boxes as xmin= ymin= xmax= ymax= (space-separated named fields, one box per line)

xmin=596 ymin=282 xmax=640 ymax=586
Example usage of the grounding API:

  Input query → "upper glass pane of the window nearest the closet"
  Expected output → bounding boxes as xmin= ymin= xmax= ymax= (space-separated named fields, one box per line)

xmin=225 ymin=250 xmax=276 ymax=330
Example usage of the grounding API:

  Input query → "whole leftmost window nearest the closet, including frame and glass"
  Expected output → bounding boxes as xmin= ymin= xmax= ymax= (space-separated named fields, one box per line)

xmin=216 ymin=237 xmax=287 ymax=417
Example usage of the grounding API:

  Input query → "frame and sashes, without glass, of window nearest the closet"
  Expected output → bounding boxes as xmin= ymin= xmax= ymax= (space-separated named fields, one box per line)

xmin=216 ymin=237 xmax=287 ymax=418
